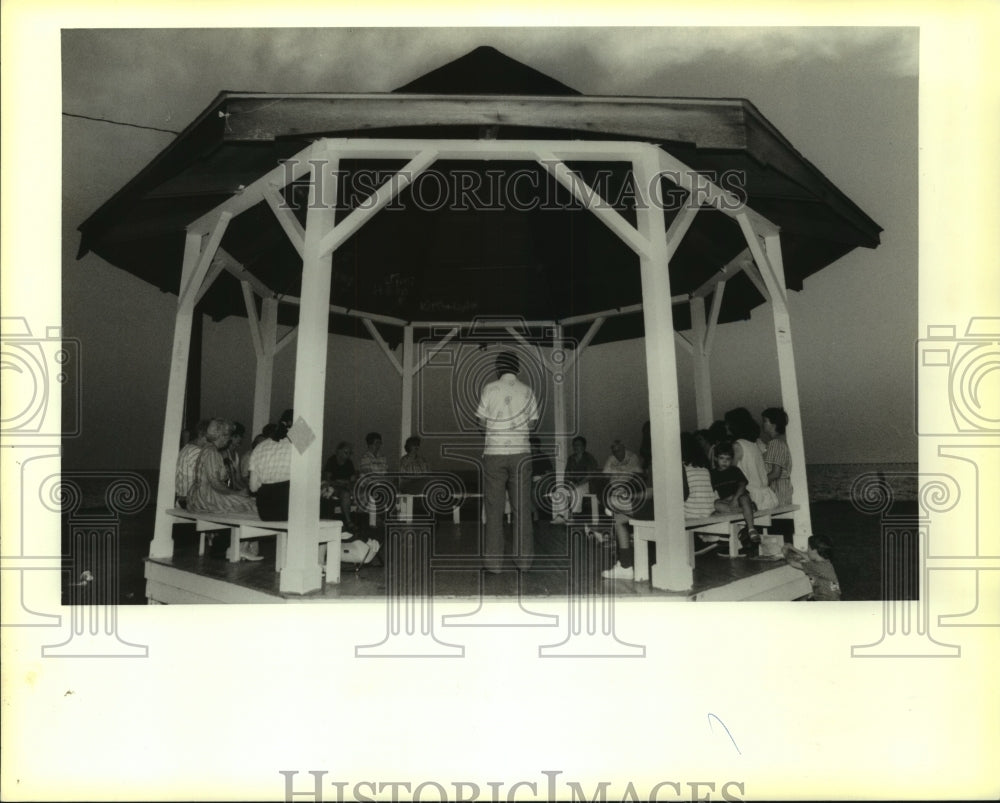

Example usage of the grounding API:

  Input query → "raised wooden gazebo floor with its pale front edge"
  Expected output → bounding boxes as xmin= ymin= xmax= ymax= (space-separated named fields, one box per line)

xmin=145 ymin=520 xmax=809 ymax=604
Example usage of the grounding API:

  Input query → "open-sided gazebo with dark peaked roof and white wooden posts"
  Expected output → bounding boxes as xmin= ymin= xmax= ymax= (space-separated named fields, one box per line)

xmin=80 ymin=47 xmax=881 ymax=594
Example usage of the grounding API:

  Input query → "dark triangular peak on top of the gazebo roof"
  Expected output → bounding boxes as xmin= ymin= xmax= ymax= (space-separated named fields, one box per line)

xmin=393 ymin=45 xmax=580 ymax=95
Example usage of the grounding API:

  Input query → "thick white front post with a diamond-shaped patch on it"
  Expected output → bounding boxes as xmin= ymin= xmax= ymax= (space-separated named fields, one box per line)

xmin=279 ymin=156 xmax=340 ymax=594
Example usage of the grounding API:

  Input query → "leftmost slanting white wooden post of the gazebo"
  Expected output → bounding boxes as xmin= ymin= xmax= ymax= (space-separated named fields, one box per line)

xmin=149 ymin=233 xmax=204 ymax=558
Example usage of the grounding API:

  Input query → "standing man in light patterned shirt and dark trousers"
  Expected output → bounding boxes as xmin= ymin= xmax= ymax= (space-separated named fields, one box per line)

xmin=476 ymin=351 xmax=538 ymax=574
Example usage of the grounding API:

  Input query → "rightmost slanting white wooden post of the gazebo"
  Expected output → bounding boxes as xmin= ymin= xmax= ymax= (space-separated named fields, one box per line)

xmin=761 ymin=229 xmax=812 ymax=549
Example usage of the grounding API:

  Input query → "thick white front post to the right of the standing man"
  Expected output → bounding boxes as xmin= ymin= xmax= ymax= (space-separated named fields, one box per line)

xmin=632 ymin=145 xmax=694 ymax=591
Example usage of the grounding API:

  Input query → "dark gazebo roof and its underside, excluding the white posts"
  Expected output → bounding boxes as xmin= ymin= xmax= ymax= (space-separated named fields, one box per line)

xmin=79 ymin=48 xmax=881 ymax=342
